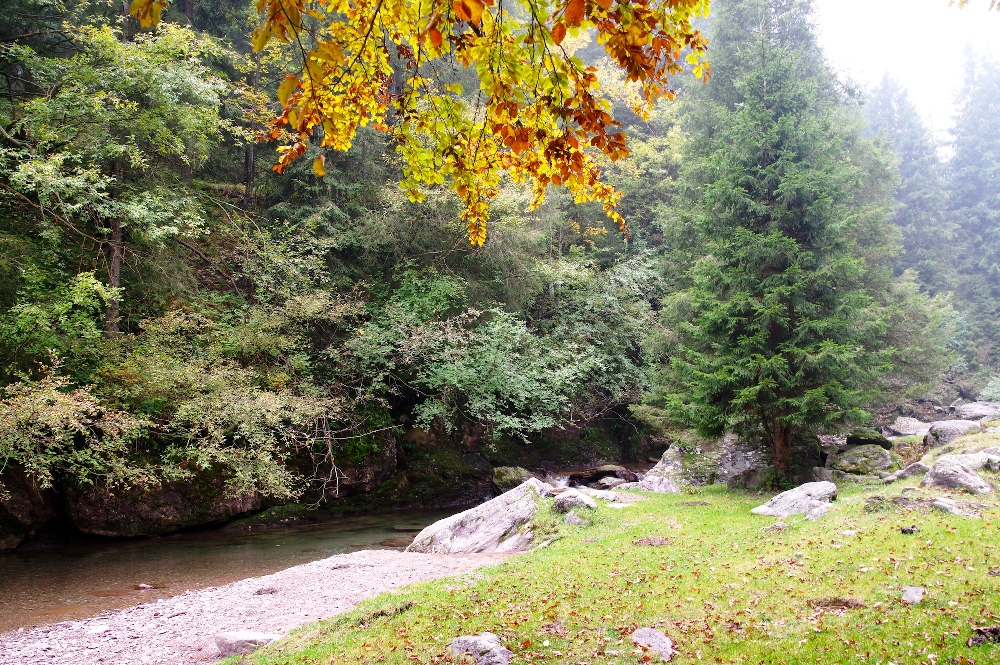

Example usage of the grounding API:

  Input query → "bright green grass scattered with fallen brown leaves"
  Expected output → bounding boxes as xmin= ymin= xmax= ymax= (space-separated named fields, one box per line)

xmin=229 ymin=479 xmax=1000 ymax=665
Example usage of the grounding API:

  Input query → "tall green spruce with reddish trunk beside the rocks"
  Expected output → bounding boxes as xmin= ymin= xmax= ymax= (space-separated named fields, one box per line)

xmin=648 ymin=0 xmax=928 ymax=476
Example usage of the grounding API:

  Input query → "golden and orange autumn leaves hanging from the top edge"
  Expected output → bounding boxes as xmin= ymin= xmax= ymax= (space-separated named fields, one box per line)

xmin=132 ymin=0 xmax=709 ymax=246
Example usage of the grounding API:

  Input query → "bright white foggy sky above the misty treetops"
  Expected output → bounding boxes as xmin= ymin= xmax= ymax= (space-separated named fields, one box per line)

xmin=814 ymin=0 xmax=1000 ymax=139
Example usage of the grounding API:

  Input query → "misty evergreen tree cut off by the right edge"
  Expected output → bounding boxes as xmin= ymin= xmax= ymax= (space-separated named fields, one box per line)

xmin=951 ymin=61 xmax=1000 ymax=360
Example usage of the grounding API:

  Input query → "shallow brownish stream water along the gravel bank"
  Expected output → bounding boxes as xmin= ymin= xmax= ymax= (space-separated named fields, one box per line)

xmin=0 ymin=509 xmax=457 ymax=633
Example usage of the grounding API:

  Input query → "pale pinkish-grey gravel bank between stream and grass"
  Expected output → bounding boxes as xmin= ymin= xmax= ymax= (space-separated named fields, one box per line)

xmin=0 ymin=550 xmax=507 ymax=665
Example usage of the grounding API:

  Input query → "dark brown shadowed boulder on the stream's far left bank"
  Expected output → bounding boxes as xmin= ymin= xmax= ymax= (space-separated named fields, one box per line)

xmin=64 ymin=472 xmax=262 ymax=537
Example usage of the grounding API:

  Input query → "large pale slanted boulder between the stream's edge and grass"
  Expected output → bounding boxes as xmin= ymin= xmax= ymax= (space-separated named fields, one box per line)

xmin=406 ymin=478 xmax=552 ymax=554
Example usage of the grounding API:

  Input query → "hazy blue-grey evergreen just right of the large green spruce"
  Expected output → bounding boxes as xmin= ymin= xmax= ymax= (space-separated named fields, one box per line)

xmin=864 ymin=75 xmax=954 ymax=293
